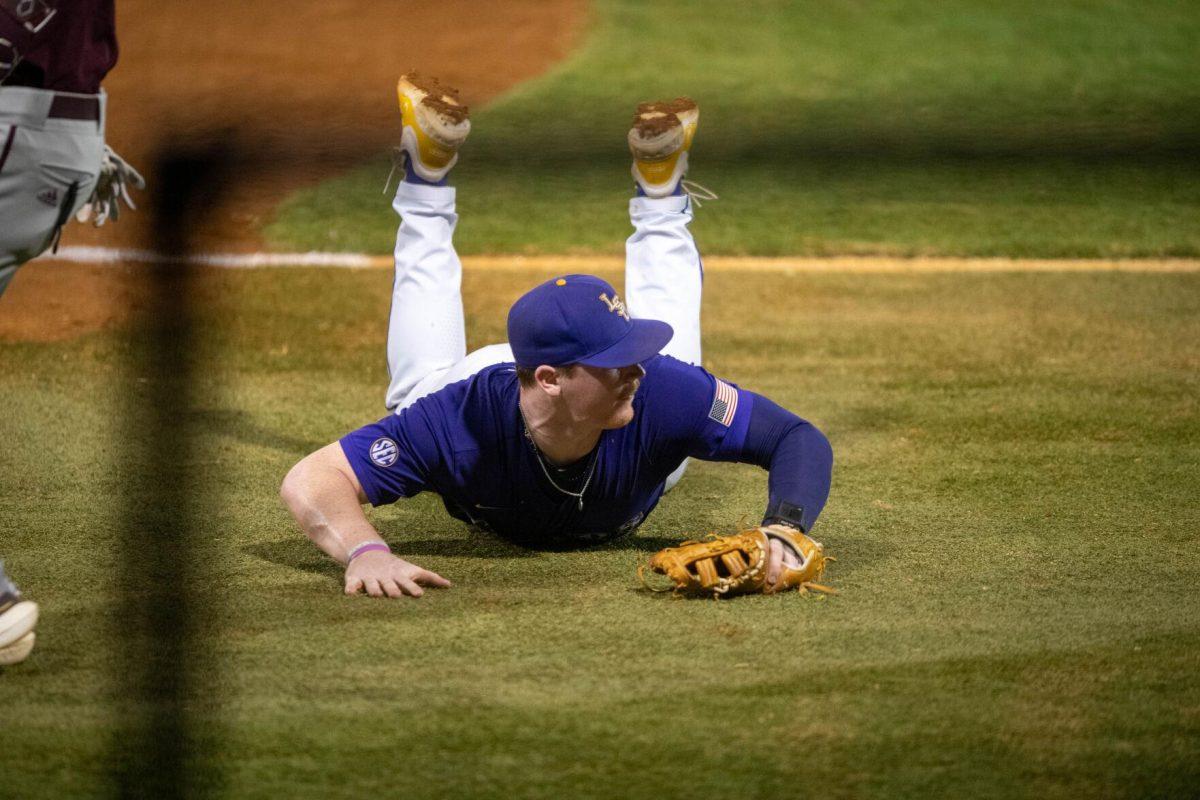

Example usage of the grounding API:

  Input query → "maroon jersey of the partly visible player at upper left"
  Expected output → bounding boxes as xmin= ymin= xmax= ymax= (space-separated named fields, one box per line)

xmin=0 ymin=0 xmax=116 ymax=95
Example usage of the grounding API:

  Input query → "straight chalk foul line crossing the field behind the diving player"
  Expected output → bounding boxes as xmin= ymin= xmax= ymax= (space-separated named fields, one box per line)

xmin=38 ymin=246 xmax=1200 ymax=273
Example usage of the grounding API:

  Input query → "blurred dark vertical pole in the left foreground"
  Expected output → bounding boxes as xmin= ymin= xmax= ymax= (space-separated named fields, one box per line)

xmin=109 ymin=148 xmax=232 ymax=800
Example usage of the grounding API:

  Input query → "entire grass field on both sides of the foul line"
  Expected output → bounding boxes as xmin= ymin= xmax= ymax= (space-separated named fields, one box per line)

xmin=7 ymin=0 xmax=1200 ymax=800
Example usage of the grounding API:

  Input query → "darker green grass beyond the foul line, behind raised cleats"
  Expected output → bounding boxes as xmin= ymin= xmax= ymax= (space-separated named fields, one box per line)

xmin=266 ymin=0 xmax=1200 ymax=257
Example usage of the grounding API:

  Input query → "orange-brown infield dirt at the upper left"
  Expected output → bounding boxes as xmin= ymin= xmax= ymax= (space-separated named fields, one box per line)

xmin=0 ymin=0 xmax=587 ymax=339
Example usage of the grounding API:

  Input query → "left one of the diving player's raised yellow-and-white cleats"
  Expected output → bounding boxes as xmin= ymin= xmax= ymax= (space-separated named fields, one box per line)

xmin=396 ymin=72 xmax=470 ymax=184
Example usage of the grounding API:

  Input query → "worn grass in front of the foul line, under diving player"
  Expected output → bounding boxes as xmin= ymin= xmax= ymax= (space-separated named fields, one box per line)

xmin=0 ymin=266 xmax=1200 ymax=800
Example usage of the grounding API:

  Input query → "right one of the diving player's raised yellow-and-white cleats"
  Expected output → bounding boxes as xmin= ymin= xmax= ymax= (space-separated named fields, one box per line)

xmin=629 ymin=97 xmax=700 ymax=197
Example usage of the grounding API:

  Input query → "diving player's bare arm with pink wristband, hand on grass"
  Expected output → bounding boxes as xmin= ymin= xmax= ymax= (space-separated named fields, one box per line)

xmin=280 ymin=441 xmax=450 ymax=597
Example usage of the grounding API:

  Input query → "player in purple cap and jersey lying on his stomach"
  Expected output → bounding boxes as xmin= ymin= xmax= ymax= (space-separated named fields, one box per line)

xmin=281 ymin=74 xmax=833 ymax=597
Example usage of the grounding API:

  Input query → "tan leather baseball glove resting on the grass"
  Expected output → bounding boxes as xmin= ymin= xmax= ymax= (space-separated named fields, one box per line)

xmin=637 ymin=525 xmax=836 ymax=597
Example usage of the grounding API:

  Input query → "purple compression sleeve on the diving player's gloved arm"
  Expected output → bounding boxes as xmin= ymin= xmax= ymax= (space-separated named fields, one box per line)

xmin=738 ymin=390 xmax=833 ymax=533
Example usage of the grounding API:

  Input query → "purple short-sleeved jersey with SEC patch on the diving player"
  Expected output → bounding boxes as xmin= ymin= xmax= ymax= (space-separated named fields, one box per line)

xmin=341 ymin=355 xmax=754 ymax=546
